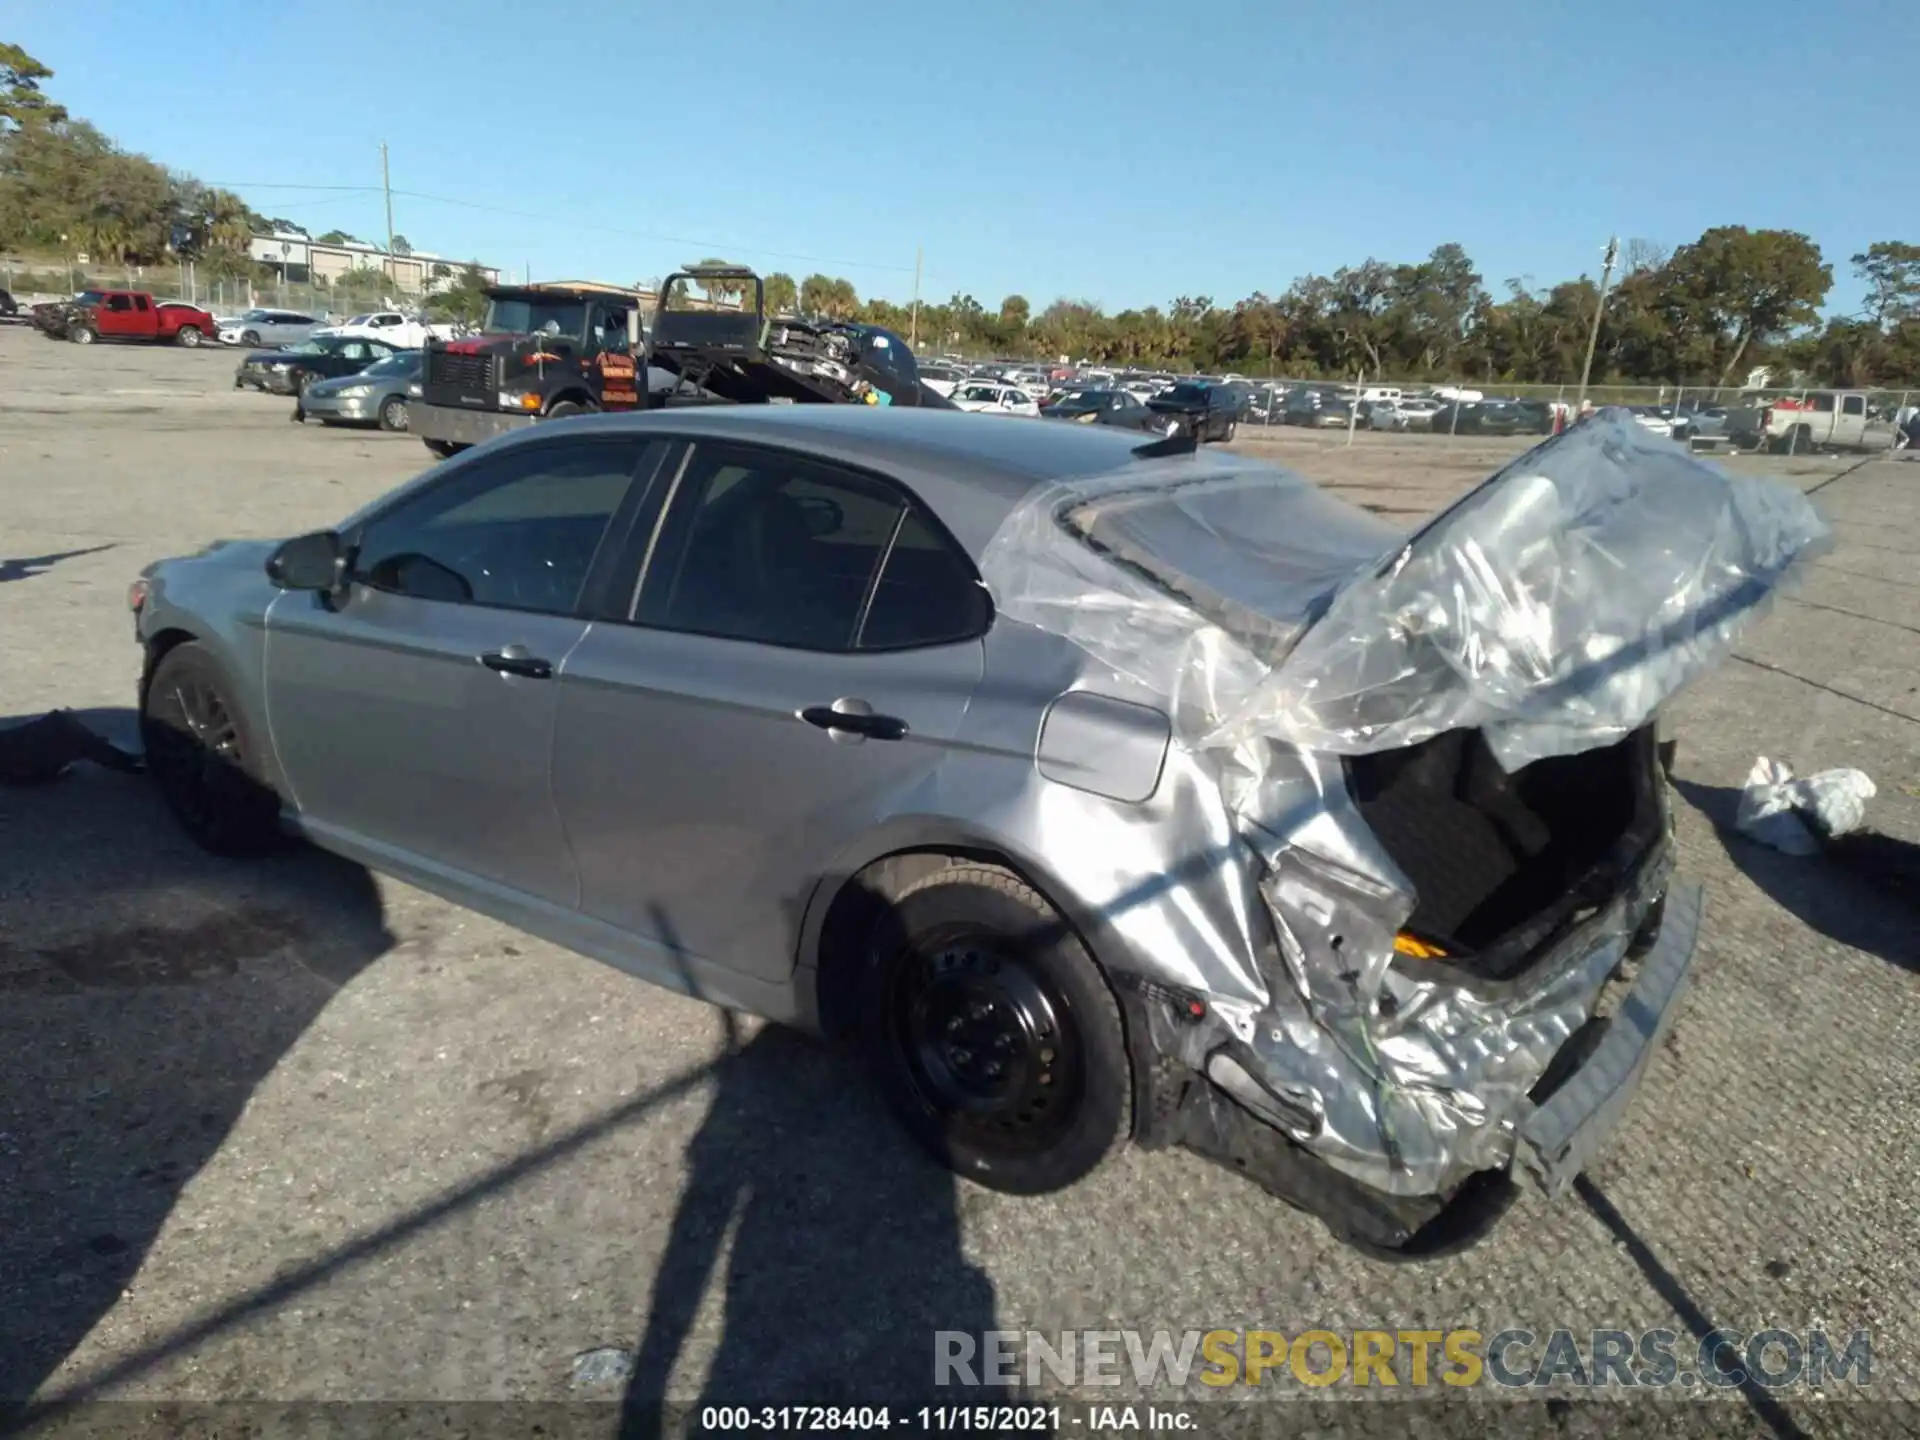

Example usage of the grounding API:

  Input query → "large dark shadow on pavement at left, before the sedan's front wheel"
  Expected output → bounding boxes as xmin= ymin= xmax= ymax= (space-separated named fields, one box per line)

xmin=0 ymin=710 xmax=394 ymax=1428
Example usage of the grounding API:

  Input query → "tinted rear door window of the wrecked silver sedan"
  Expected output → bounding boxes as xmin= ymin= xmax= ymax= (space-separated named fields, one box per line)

xmin=634 ymin=445 xmax=987 ymax=651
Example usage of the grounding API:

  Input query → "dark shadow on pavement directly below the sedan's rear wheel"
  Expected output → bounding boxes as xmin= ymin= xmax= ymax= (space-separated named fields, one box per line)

xmin=620 ymin=1014 xmax=1018 ymax=1436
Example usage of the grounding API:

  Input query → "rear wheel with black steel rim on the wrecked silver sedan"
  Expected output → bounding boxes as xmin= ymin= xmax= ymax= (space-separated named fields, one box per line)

xmin=860 ymin=862 xmax=1133 ymax=1194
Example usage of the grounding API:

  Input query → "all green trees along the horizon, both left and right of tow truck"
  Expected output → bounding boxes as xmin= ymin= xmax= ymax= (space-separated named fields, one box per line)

xmin=0 ymin=42 xmax=1920 ymax=386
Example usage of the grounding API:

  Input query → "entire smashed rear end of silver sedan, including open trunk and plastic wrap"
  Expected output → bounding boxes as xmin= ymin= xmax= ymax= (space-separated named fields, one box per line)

xmin=981 ymin=413 xmax=1828 ymax=1258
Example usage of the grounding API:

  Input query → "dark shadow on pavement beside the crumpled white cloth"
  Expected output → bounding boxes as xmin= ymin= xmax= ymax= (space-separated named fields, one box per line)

xmin=1672 ymin=780 xmax=1920 ymax=972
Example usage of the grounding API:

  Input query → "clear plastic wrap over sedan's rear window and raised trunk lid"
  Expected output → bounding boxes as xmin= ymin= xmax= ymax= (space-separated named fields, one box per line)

xmin=981 ymin=411 xmax=1832 ymax=770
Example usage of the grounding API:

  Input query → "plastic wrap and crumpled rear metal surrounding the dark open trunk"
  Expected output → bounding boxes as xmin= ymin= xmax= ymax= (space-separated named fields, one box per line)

xmin=981 ymin=422 xmax=1781 ymax=1194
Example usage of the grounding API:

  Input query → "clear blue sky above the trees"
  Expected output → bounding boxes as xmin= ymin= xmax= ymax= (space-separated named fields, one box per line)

xmin=0 ymin=0 xmax=1920 ymax=309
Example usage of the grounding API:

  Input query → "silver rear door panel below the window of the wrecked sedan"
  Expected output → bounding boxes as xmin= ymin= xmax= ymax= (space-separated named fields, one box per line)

xmin=553 ymin=624 xmax=983 ymax=981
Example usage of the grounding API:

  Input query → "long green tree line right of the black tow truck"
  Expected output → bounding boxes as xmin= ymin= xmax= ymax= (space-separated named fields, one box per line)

xmin=716 ymin=240 xmax=1920 ymax=388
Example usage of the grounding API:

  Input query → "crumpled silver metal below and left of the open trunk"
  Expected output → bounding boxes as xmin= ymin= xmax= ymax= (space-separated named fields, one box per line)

xmin=1221 ymin=743 xmax=1672 ymax=1196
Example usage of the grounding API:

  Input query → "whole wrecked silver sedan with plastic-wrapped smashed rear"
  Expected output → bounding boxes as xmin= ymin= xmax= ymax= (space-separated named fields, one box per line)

xmin=131 ymin=405 xmax=1818 ymax=1256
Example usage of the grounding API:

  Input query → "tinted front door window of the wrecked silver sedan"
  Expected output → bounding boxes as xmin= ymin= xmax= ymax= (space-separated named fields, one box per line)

xmin=353 ymin=440 xmax=641 ymax=614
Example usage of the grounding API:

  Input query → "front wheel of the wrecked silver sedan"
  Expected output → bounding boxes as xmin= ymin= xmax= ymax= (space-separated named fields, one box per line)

xmin=140 ymin=641 xmax=282 ymax=856
